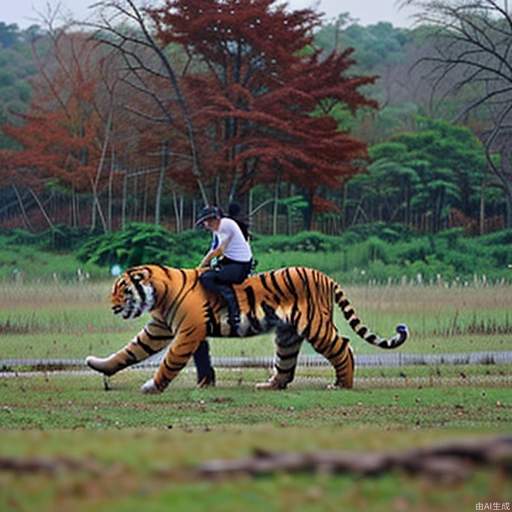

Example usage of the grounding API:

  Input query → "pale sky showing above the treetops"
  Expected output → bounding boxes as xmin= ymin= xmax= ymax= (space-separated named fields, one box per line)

xmin=0 ymin=0 xmax=412 ymax=28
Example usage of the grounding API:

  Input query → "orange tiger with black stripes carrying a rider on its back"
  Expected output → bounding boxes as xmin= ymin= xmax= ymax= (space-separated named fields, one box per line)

xmin=86 ymin=265 xmax=409 ymax=394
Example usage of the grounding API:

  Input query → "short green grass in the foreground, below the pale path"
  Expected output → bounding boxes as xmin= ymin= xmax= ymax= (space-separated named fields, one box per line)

xmin=0 ymin=371 xmax=512 ymax=511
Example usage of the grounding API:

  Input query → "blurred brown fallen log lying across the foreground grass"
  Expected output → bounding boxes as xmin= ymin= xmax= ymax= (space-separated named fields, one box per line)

xmin=0 ymin=437 xmax=512 ymax=483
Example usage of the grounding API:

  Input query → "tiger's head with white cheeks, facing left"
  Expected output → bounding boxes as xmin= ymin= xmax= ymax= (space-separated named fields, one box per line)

xmin=111 ymin=267 xmax=156 ymax=319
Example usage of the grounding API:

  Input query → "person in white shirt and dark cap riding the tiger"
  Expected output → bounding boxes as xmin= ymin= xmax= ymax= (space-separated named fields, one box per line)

xmin=196 ymin=206 xmax=252 ymax=336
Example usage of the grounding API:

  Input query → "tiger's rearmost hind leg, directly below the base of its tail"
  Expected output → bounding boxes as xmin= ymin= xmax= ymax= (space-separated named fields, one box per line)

xmin=311 ymin=325 xmax=354 ymax=389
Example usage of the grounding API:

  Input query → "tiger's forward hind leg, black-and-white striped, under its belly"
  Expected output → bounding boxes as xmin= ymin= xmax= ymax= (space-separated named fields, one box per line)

xmin=256 ymin=324 xmax=304 ymax=389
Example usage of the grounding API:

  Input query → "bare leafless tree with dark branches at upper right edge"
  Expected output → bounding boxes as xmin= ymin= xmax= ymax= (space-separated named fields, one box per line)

xmin=403 ymin=0 xmax=512 ymax=227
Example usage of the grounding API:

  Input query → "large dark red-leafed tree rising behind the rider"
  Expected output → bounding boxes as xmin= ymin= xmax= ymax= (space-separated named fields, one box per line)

xmin=148 ymin=0 xmax=375 ymax=226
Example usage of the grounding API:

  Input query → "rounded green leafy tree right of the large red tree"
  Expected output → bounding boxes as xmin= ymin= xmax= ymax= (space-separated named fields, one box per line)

xmin=349 ymin=118 xmax=486 ymax=231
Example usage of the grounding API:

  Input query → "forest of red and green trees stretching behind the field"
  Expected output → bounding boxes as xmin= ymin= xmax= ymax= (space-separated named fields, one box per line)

xmin=0 ymin=0 xmax=512 ymax=235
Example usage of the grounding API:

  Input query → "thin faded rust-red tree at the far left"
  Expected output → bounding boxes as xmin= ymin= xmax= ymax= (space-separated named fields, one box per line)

xmin=2 ymin=31 xmax=116 ymax=229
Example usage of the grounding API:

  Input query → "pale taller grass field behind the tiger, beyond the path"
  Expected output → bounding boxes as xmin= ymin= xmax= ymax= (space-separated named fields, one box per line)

xmin=0 ymin=282 xmax=512 ymax=359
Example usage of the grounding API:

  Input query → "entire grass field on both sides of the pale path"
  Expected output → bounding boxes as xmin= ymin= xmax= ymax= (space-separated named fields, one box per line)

xmin=0 ymin=283 xmax=512 ymax=512
